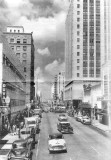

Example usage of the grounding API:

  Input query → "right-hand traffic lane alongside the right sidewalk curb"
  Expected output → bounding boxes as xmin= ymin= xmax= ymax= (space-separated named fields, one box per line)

xmin=69 ymin=115 xmax=111 ymax=160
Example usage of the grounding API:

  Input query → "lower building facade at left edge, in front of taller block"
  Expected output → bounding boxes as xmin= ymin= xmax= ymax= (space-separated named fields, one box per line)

xmin=0 ymin=35 xmax=26 ymax=132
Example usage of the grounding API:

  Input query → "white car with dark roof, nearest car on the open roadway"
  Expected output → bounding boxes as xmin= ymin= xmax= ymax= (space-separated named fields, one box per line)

xmin=48 ymin=133 xmax=67 ymax=153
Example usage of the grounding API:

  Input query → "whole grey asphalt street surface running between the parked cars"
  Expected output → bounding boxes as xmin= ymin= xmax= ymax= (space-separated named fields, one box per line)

xmin=33 ymin=112 xmax=111 ymax=160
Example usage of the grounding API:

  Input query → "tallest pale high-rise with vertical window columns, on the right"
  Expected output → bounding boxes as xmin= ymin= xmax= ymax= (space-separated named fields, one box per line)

xmin=65 ymin=0 xmax=101 ymax=104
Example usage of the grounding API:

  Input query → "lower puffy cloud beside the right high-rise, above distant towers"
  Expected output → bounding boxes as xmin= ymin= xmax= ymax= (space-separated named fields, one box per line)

xmin=45 ymin=60 xmax=65 ymax=76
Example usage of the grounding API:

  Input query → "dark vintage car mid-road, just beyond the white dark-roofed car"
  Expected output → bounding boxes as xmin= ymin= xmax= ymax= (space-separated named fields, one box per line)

xmin=57 ymin=121 xmax=73 ymax=133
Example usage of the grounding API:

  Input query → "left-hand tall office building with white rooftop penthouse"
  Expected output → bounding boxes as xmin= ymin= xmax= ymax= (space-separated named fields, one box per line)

xmin=4 ymin=26 xmax=35 ymax=103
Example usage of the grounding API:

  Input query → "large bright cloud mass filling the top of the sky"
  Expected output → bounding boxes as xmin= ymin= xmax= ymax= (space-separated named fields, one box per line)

xmin=1 ymin=0 xmax=68 ymax=42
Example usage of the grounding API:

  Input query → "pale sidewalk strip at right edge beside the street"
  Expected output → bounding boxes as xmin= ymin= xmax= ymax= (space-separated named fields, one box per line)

xmin=92 ymin=120 xmax=111 ymax=133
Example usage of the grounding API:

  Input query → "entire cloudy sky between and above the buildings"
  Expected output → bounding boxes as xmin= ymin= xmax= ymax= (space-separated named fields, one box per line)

xmin=0 ymin=0 xmax=69 ymax=98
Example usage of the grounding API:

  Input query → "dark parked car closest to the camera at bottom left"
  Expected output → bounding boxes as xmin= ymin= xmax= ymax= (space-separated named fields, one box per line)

xmin=9 ymin=139 xmax=33 ymax=160
